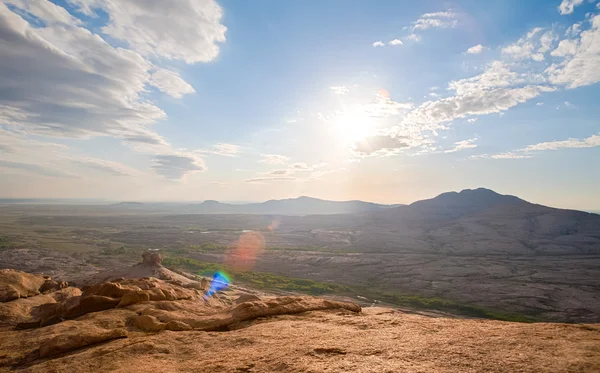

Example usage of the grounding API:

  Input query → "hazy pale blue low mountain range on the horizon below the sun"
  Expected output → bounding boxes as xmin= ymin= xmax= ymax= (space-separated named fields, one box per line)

xmin=110 ymin=196 xmax=402 ymax=215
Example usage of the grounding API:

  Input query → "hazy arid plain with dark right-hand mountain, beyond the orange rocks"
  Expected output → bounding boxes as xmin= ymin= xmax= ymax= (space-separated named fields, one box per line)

xmin=0 ymin=189 xmax=600 ymax=322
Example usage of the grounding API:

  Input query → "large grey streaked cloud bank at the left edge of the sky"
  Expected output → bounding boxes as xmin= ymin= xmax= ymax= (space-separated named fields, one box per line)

xmin=0 ymin=4 xmax=165 ymax=142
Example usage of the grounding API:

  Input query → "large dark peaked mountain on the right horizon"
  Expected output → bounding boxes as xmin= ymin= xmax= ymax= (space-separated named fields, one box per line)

xmin=336 ymin=188 xmax=600 ymax=254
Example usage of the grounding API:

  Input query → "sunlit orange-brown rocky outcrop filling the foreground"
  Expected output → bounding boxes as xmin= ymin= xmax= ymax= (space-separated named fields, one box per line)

xmin=0 ymin=258 xmax=600 ymax=372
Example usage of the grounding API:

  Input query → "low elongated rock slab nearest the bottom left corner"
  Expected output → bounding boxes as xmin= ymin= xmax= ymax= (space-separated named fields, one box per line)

xmin=39 ymin=328 xmax=127 ymax=358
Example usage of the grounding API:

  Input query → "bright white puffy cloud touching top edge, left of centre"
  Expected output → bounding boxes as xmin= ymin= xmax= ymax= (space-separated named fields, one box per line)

xmin=68 ymin=0 xmax=227 ymax=63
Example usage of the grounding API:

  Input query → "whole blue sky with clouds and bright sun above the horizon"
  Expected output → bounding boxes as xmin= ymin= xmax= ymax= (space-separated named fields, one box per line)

xmin=0 ymin=0 xmax=600 ymax=210
